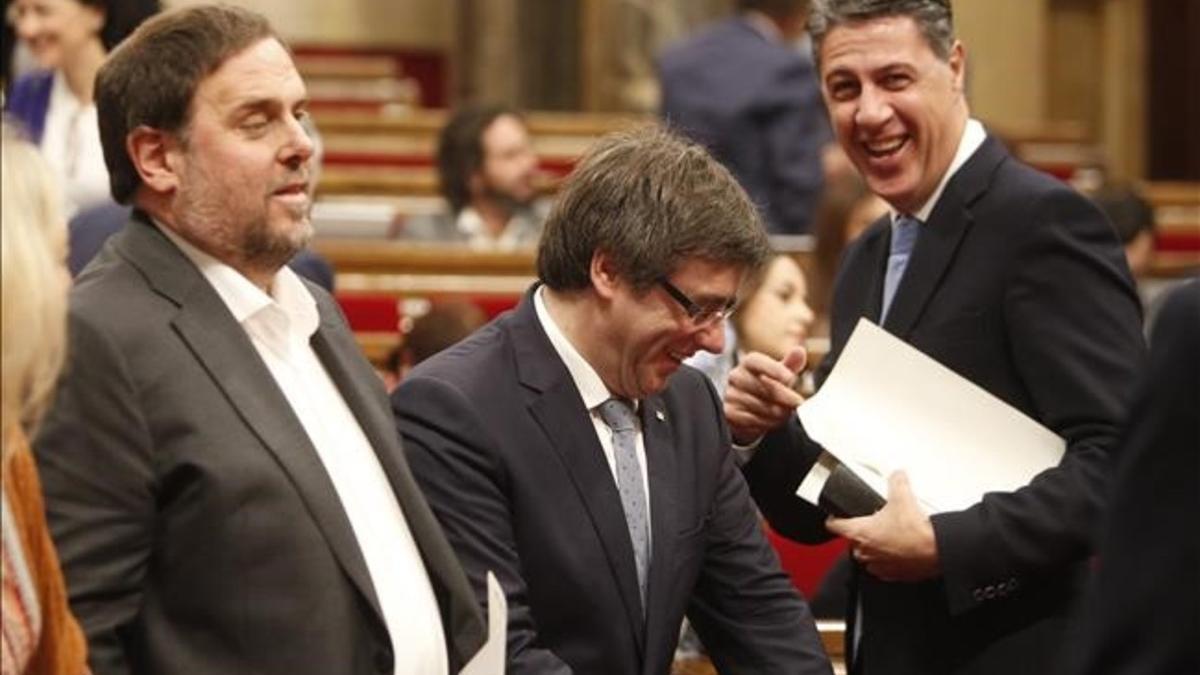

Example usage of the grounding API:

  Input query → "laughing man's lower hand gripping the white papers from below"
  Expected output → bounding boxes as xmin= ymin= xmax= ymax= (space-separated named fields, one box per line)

xmin=826 ymin=471 xmax=941 ymax=581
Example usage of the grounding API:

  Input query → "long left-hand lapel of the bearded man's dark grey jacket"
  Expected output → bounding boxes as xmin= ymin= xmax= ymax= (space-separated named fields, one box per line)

xmin=118 ymin=214 xmax=383 ymax=620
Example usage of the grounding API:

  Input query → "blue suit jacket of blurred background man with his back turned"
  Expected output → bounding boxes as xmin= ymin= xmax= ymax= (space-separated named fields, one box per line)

xmin=659 ymin=17 xmax=830 ymax=234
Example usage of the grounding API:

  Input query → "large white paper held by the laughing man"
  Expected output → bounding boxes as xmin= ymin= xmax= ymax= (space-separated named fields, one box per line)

xmin=797 ymin=319 xmax=1067 ymax=514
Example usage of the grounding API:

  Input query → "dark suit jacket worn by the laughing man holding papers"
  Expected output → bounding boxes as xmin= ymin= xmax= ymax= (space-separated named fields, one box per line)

xmin=745 ymin=138 xmax=1145 ymax=675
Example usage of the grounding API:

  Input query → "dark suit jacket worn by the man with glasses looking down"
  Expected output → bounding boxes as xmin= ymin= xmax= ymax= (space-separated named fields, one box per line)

xmin=392 ymin=293 xmax=829 ymax=675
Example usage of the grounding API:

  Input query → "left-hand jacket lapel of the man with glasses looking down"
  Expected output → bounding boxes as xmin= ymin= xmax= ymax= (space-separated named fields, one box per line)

xmin=510 ymin=288 xmax=653 ymax=652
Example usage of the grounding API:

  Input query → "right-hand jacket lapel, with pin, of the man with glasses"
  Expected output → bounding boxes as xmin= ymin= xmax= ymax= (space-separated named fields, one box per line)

xmin=641 ymin=395 xmax=679 ymax=658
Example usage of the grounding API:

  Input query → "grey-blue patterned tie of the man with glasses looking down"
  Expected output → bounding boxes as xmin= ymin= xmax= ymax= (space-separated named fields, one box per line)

xmin=600 ymin=399 xmax=650 ymax=611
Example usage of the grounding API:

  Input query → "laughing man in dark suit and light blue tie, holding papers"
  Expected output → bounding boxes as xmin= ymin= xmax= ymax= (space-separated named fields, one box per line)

xmin=725 ymin=0 xmax=1144 ymax=675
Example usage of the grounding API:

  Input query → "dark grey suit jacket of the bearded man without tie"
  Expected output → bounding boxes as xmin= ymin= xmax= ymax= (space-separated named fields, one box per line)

xmin=36 ymin=211 xmax=484 ymax=675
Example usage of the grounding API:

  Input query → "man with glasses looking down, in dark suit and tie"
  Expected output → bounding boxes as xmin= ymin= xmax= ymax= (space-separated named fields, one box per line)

xmin=392 ymin=126 xmax=830 ymax=675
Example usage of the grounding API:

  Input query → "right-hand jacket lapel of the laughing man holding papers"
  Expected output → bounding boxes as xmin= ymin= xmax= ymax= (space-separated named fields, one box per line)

xmin=875 ymin=137 xmax=1007 ymax=336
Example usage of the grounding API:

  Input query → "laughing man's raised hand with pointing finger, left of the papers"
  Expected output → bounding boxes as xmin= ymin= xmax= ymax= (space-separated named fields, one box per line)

xmin=724 ymin=347 xmax=808 ymax=446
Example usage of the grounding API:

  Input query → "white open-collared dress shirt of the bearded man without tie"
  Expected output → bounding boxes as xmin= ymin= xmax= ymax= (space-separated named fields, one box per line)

xmin=160 ymin=225 xmax=449 ymax=675
